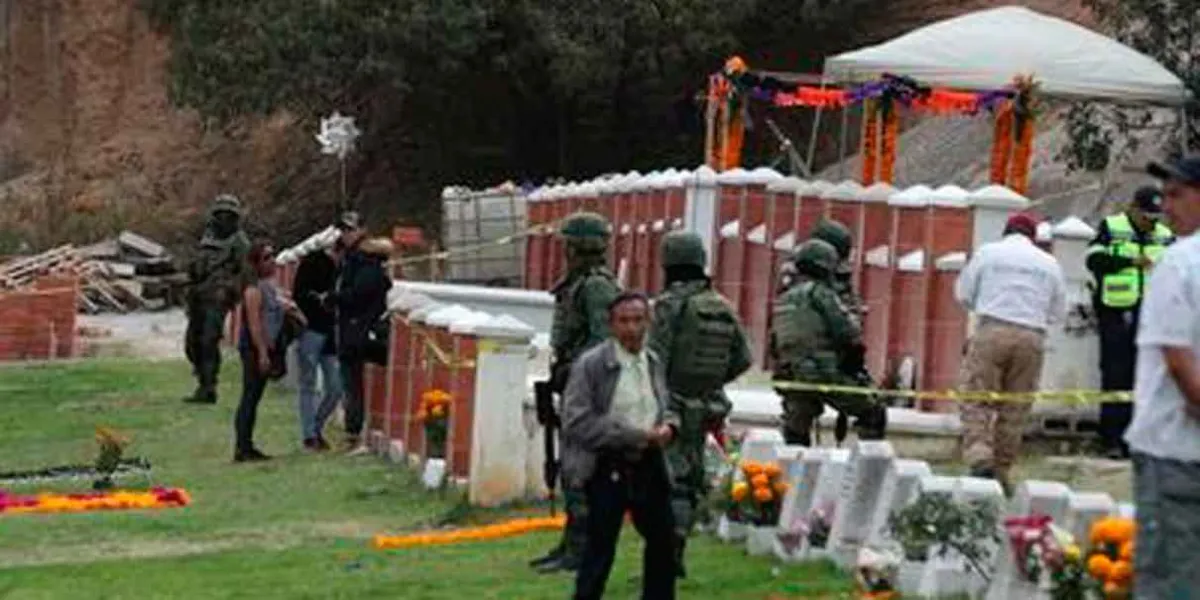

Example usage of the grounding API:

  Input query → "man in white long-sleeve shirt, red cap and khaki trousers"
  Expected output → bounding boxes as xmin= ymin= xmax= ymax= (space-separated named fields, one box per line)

xmin=954 ymin=214 xmax=1067 ymax=490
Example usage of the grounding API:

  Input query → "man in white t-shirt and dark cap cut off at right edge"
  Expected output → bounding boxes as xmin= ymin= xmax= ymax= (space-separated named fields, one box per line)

xmin=1124 ymin=155 xmax=1200 ymax=600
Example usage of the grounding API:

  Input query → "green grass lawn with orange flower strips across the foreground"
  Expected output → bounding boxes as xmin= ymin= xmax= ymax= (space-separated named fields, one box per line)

xmin=0 ymin=360 xmax=851 ymax=600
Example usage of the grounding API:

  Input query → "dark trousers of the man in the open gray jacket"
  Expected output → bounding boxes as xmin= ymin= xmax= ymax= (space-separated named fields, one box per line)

xmin=575 ymin=450 xmax=676 ymax=600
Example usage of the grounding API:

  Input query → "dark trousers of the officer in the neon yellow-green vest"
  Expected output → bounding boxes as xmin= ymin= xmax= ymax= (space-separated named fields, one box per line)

xmin=1096 ymin=307 xmax=1138 ymax=451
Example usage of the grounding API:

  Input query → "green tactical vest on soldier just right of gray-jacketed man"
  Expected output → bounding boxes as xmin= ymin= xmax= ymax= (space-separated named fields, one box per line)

xmin=667 ymin=288 xmax=742 ymax=396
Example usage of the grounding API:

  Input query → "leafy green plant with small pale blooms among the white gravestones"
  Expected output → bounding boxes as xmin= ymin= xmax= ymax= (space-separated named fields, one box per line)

xmin=888 ymin=493 xmax=1000 ymax=582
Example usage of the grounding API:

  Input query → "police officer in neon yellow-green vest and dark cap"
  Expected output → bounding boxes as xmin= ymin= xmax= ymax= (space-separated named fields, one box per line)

xmin=1087 ymin=187 xmax=1175 ymax=458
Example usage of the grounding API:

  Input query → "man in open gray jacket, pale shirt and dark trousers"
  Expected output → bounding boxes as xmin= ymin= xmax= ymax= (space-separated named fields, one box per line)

xmin=563 ymin=293 xmax=679 ymax=600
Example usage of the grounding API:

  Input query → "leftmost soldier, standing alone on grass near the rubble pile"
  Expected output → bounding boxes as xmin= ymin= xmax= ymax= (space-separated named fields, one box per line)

xmin=184 ymin=194 xmax=250 ymax=404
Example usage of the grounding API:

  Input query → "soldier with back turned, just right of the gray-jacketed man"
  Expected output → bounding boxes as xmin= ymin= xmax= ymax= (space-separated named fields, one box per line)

xmin=649 ymin=232 xmax=751 ymax=577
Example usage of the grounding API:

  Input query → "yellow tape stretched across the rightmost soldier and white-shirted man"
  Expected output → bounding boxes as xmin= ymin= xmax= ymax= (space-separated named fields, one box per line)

xmin=770 ymin=380 xmax=1133 ymax=406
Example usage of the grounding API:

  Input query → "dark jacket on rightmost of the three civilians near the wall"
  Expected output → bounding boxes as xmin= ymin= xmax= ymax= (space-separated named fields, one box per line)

xmin=336 ymin=240 xmax=391 ymax=360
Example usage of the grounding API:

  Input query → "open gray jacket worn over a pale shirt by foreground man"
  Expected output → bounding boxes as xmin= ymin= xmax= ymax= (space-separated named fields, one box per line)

xmin=562 ymin=338 xmax=679 ymax=485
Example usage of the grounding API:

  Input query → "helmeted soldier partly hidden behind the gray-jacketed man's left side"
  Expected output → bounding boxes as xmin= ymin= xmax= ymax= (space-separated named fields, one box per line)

xmin=532 ymin=211 xmax=620 ymax=572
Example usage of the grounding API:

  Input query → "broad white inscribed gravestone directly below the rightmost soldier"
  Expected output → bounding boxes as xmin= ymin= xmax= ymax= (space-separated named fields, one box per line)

xmin=829 ymin=440 xmax=895 ymax=566
